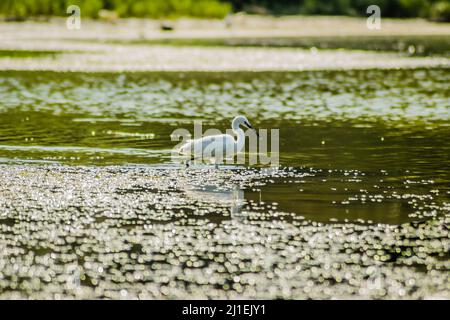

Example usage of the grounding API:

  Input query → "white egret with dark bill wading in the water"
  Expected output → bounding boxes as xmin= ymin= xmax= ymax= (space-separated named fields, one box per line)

xmin=178 ymin=116 xmax=258 ymax=167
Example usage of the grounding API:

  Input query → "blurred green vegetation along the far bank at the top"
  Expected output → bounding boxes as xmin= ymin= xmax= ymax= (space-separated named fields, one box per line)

xmin=0 ymin=0 xmax=450 ymax=21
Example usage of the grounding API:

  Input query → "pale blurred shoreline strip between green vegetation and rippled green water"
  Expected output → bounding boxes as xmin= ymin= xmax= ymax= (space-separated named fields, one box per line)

xmin=0 ymin=16 xmax=450 ymax=72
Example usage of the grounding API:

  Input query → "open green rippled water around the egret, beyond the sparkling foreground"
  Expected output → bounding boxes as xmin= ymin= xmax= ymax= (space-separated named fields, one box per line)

xmin=0 ymin=69 xmax=450 ymax=223
